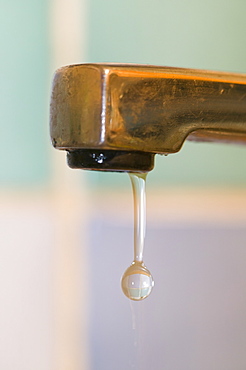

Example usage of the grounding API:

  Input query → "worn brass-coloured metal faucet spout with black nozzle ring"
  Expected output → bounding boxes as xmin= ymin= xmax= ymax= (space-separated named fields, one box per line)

xmin=50 ymin=64 xmax=246 ymax=172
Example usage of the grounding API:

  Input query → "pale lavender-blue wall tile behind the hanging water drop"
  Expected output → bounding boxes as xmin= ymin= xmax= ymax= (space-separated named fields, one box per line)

xmin=89 ymin=218 xmax=246 ymax=370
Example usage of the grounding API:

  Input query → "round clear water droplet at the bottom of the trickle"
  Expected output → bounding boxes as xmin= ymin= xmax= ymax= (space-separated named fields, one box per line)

xmin=121 ymin=261 xmax=154 ymax=301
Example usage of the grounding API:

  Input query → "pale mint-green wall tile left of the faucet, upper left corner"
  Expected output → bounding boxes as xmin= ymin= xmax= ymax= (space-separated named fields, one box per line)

xmin=0 ymin=0 xmax=50 ymax=187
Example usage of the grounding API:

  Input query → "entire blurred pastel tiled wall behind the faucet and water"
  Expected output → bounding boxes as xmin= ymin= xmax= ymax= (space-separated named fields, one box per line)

xmin=0 ymin=0 xmax=246 ymax=370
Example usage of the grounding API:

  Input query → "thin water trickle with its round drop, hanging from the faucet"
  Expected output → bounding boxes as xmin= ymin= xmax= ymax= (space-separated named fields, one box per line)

xmin=121 ymin=173 xmax=154 ymax=301
